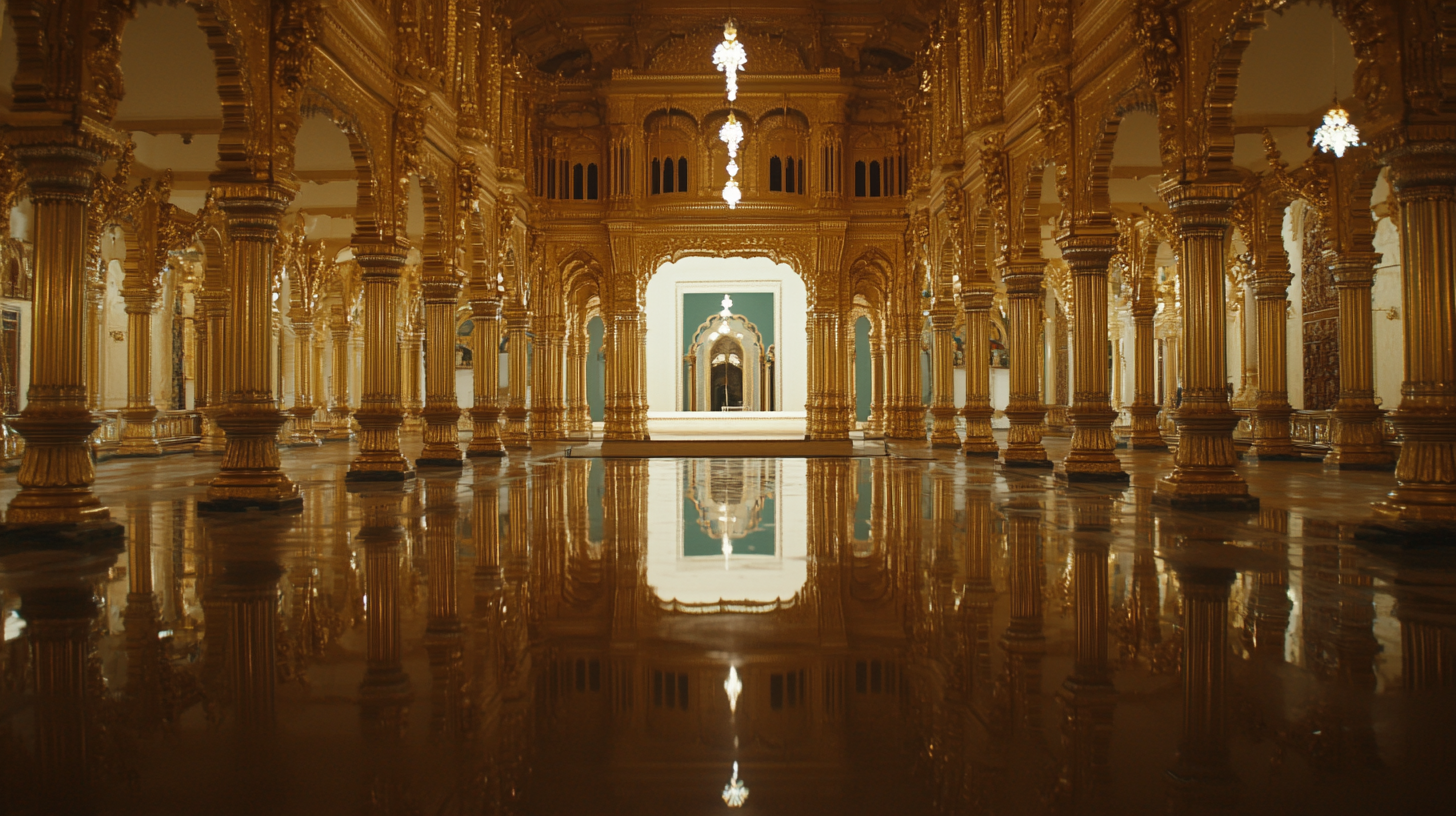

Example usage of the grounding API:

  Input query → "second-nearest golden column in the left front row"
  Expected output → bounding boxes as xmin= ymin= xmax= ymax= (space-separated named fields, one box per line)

xmin=198 ymin=184 xmax=303 ymax=511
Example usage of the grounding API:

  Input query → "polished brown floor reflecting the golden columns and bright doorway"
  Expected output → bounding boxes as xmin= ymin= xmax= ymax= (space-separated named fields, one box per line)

xmin=0 ymin=443 xmax=1456 ymax=816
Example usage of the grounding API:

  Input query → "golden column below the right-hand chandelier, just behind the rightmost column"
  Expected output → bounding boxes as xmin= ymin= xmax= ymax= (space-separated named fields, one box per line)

xmin=1325 ymin=252 xmax=1395 ymax=471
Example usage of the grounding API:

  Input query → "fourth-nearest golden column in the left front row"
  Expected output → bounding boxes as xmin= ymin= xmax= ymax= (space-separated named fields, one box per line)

xmin=415 ymin=273 xmax=464 ymax=468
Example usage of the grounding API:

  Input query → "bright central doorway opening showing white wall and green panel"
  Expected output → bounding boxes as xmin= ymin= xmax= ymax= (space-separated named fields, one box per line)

xmin=644 ymin=258 xmax=808 ymax=437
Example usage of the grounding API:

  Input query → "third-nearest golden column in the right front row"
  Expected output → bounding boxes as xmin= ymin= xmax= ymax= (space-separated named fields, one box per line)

xmin=1057 ymin=230 xmax=1127 ymax=482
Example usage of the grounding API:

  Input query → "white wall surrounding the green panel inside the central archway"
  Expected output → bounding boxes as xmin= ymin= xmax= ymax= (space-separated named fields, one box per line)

xmin=645 ymin=258 xmax=808 ymax=412
